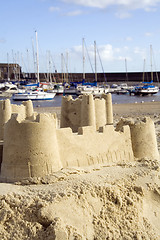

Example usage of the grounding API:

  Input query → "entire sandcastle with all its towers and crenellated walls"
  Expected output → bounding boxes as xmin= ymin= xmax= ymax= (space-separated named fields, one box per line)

xmin=0 ymin=94 xmax=159 ymax=182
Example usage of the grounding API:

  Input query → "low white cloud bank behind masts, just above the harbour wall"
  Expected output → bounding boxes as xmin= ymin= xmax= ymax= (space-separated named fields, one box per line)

xmin=64 ymin=44 xmax=154 ymax=72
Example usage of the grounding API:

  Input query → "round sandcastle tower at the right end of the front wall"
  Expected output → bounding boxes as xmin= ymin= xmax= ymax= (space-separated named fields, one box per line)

xmin=117 ymin=117 xmax=159 ymax=159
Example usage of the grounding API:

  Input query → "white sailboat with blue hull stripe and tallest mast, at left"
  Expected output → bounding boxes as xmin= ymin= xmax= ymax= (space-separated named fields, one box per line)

xmin=12 ymin=31 xmax=56 ymax=101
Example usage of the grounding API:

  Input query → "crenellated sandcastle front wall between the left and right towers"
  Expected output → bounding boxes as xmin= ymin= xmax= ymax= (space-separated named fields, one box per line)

xmin=57 ymin=125 xmax=134 ymax=167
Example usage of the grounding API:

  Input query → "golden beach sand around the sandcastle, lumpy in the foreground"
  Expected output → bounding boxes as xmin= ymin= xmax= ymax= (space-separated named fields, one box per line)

xmin=0 ymin=102 xmax=160 ymax=240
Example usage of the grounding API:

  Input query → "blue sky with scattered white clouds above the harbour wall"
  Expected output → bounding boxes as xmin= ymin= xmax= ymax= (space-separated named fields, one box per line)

xmin=0 ymin=0 xmax=160 ymax=73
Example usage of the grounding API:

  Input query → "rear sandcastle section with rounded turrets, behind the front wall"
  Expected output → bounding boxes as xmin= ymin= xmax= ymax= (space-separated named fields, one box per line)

xmin=60 ymin=93 xmax=113 ymax=132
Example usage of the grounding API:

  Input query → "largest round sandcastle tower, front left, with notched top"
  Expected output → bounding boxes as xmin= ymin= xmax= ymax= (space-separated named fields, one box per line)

xmin=1 ymin=114 xmax=62 ymax=182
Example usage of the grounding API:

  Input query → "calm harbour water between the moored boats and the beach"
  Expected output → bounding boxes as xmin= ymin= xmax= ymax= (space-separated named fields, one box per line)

xmin=1 ymin=92 xmax=160 ymax=107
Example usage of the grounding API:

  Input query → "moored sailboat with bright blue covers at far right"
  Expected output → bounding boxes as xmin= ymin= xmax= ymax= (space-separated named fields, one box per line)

xmin=131 ymin=45 xmax=159 ymax=96
